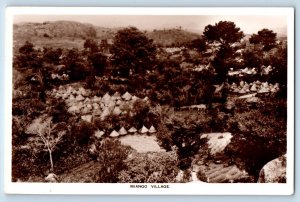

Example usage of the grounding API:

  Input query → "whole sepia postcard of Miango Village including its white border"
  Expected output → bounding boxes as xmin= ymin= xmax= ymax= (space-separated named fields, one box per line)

xmin=5 ymin=7 xmax=294 ymax=194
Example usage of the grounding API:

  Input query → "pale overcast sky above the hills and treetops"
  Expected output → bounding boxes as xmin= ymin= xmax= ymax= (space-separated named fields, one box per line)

xmin=14 ymin=15 xmax=287 ymax=35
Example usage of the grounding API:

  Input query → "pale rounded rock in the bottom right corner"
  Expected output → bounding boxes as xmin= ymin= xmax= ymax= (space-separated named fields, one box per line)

xmin=257 ymin=154 xmax=286 ymax=183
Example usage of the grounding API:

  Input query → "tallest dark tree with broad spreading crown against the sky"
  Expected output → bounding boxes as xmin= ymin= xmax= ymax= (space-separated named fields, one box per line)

xmin=203 ymin=21 xmax=245 ymax=82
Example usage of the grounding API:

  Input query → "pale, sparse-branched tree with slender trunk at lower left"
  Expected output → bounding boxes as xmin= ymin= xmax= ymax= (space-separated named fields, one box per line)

xmin=26 ymin=117 xmax=66 ymax=172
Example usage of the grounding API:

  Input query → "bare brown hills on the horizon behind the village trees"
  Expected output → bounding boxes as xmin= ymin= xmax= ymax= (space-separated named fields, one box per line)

xmin=13 ymin=21 xmax=199 ymax=49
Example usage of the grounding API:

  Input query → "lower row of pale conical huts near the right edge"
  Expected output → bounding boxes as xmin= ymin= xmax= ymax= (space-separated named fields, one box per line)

xmin=230 ymin=81 xmax=279 ymax=94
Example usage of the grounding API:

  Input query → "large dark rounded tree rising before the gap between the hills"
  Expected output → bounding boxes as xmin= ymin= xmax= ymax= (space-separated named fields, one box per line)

xmin=111 ymin=27 xmax=156 ymax=76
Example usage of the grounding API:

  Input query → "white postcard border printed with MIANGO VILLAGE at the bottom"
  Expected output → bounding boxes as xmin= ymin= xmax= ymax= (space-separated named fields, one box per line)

xmin=4 ymin=7 xmax=295 ymax=195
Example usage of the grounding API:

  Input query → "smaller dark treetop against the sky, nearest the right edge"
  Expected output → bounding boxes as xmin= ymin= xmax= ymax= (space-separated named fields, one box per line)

xmin=249 ymin=29 xmax=277 ymax=51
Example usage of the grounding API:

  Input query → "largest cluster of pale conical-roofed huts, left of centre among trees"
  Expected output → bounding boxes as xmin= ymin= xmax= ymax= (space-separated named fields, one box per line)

xmin=52 ymin=86 xmax=149 ymax=122
